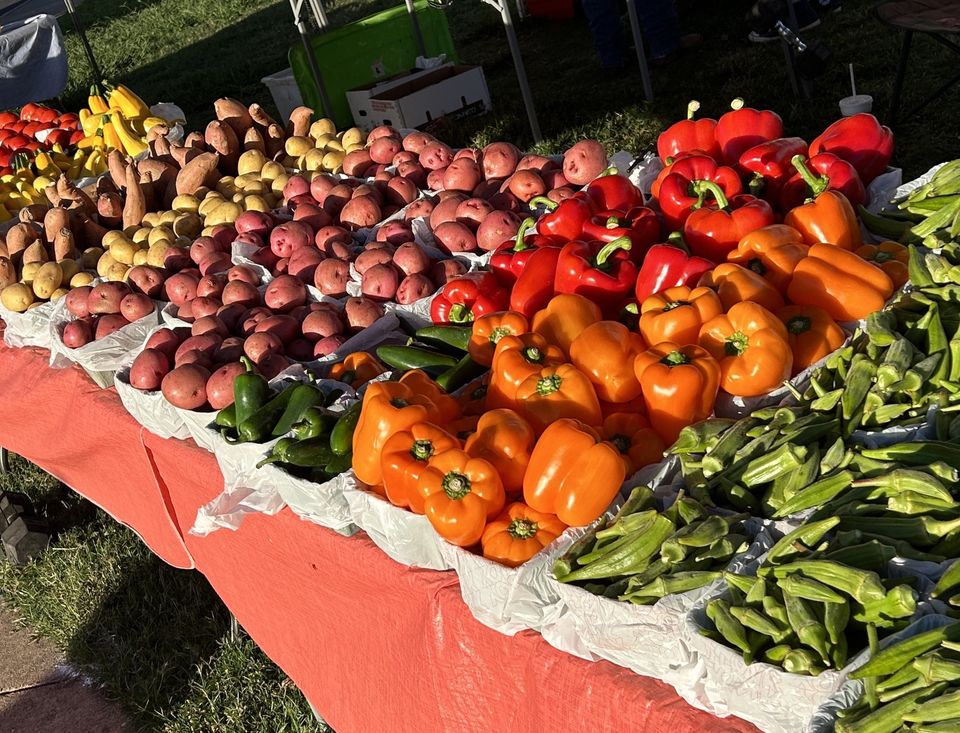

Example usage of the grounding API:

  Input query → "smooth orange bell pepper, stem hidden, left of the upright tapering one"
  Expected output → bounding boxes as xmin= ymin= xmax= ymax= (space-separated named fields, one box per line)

xmin=570 ymin=321 xmax=646 ymax=402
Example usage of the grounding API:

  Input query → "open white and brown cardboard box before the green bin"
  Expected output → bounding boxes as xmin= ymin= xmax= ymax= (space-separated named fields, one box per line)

xmin=347 ymin=64 xmax=490 ymax=130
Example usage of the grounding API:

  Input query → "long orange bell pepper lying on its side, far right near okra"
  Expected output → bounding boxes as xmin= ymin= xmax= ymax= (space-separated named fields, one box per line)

xmin=787 ymin=244 xmax=893 ymax=321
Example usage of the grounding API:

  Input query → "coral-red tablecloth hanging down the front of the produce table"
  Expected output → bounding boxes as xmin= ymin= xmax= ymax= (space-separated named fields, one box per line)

xmin=0 ymin=338 xmax=756 ymax=733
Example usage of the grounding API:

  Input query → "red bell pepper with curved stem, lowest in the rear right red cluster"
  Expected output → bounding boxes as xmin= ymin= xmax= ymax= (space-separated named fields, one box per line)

xmin=683 ymin=181 xmax=776 ymax=263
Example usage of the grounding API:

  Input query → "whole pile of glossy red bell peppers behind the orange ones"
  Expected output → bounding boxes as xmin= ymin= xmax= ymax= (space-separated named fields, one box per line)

xmin=431 ymin=100 xmax=893 ymax=323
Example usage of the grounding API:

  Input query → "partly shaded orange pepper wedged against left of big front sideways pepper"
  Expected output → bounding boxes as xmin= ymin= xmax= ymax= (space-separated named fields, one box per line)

xmin=463 ymin=409 xmax=537 ymax=494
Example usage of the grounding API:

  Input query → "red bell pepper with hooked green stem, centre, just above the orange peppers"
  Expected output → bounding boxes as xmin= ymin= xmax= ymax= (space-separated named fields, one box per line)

xmin=554 ymin=237 xmax=637 ymax=317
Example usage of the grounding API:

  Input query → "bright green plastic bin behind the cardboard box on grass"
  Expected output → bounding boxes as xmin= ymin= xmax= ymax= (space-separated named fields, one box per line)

xmin=289 ymin=0 xmax=457 ymax=129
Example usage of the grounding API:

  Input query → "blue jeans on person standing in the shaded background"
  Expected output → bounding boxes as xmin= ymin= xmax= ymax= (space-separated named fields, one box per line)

xmin=583 ymin=0 xmax=680 ymax=67
